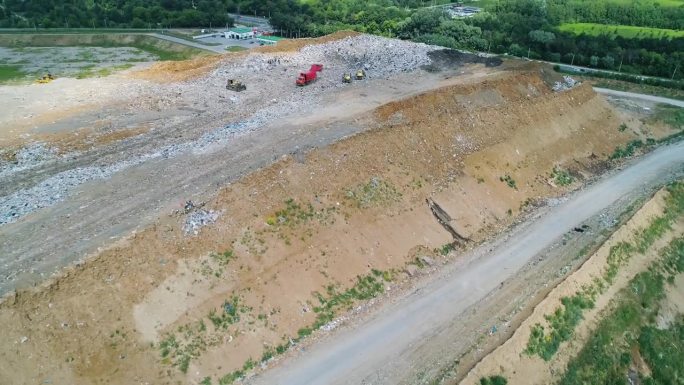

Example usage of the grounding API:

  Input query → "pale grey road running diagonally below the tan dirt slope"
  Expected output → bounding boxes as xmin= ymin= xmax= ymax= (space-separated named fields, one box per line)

xmin=249 ymin=142 xmax=684 ymax=385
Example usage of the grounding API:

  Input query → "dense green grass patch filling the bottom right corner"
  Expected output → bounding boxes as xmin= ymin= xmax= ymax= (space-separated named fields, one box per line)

xmin=560 ymin=238 xmax=684 ymax=385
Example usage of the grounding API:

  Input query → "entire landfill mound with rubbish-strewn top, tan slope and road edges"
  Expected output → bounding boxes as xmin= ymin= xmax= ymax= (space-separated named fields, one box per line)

xmin=0 ymin=33 xmax=681 ymax=385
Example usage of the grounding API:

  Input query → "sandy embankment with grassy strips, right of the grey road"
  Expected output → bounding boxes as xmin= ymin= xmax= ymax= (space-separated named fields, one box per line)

xmin=461 ymin=182 xmax=684 ymax=385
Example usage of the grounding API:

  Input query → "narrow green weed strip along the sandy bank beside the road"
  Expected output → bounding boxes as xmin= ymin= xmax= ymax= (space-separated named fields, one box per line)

xmin=523 ymin=182 xmax=684 ymax=361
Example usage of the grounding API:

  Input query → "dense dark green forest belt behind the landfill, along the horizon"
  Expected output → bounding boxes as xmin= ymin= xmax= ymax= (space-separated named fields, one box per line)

xmin=0 ymin=0 xmax=684 ymax=79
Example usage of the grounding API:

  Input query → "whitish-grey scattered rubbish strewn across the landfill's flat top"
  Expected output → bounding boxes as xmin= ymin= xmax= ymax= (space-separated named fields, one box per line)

xmin=0 ymin=35 xmax=437 ymax=226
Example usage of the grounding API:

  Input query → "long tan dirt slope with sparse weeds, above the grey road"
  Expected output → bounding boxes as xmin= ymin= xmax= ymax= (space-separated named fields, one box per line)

xmin=0 ymin=67 xmax=664 ymax=384
